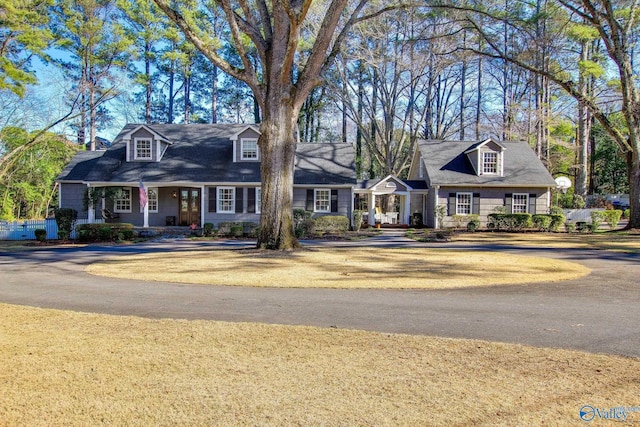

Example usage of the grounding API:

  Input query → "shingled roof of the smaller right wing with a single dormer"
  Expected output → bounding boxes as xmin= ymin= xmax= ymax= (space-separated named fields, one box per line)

xmin=418 ymin=140 xmax=556 ymax=187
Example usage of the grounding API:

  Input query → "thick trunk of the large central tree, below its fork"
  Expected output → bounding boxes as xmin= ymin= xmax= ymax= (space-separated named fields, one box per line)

xmin=258 ymin=99 xmax=299 ymax=249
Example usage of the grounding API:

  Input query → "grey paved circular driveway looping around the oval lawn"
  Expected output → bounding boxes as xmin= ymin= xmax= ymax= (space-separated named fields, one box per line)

xmin=0 ymin=233 xmax=640 ymax=357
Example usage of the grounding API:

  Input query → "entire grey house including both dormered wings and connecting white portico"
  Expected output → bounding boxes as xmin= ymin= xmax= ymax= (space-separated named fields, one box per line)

xmin=57 ymin=124 xmax=556 ymax=231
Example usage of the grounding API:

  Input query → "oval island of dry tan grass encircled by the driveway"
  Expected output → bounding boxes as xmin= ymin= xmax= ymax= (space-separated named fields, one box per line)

xmin=87 ymin=248 xmax=589 ymax=289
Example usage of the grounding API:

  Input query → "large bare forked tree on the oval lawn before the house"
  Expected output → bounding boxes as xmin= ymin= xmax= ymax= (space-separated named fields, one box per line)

xmin=155 ymin=0 xmax=404 ymax=249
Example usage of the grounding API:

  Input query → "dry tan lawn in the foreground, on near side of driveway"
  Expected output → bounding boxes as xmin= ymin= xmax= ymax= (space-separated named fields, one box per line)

xmin=0 ymin=304 xmax=640 ymax=426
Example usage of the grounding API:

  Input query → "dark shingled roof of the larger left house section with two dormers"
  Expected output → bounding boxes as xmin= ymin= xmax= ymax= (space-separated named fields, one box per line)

xmin=58 ymin=124 xmax=356 ymax=185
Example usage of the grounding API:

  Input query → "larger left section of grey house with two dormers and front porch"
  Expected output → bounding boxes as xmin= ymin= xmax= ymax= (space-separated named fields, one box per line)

xmin=57 ymin=124 xmax=356 ymax=226
